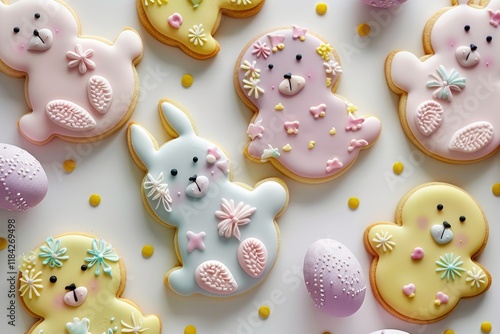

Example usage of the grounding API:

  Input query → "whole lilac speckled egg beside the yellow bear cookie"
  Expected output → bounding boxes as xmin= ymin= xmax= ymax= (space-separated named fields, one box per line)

xmin=304 ymin=239 xmax=366 ymax=317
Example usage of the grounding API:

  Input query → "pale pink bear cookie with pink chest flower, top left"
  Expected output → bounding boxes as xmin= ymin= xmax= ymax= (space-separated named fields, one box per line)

xmin=0 ymin=0 xmax=142 ymax=144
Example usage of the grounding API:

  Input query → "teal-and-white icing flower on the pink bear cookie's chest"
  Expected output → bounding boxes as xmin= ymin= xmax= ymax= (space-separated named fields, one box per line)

xmin=426 ymin=65 xmax=465 ymax=102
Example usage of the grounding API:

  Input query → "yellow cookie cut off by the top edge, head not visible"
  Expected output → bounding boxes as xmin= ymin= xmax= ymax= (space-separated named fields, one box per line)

xmin=136 ymin=0 xmax=264 ymax=59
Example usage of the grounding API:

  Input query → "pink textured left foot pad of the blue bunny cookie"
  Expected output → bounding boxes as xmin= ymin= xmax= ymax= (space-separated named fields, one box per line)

xmin=195 ymin=261 xmax=238 ymax=295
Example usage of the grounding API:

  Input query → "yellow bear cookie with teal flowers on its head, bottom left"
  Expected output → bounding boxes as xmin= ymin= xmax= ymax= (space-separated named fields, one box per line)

xmin=18 ymin=234 xmax=161 ymax=334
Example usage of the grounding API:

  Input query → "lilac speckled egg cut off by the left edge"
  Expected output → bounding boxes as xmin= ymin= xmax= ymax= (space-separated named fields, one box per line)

xmin=0 ymin=143 xmax=48 ymax=211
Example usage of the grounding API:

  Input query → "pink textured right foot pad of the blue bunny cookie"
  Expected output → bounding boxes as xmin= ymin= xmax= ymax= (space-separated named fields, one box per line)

xmin=238 ymin=238 xmax=267 ymax=278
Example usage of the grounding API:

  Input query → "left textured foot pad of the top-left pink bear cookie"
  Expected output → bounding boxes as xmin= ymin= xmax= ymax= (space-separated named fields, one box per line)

xmin=45 ymin=100 xmax=96 ymax=131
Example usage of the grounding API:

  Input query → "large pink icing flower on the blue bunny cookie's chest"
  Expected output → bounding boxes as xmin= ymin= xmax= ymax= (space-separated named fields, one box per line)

xmin=215 ymin=198 xmax=256 ymax=240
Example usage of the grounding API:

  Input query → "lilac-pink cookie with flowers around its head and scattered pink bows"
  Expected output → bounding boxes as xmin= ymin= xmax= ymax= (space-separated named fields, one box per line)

xmin=234 ymin=26 xmax=381 ymax=183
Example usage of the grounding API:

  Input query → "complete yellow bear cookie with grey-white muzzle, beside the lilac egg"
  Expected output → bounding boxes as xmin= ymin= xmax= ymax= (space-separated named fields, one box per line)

xmin=364 ymin=182 xmax=491 ymax=323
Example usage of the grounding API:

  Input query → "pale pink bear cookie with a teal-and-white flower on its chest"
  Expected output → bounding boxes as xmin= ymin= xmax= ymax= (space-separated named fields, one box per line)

xmin=385 ymin=0 xmax=500 ymax=163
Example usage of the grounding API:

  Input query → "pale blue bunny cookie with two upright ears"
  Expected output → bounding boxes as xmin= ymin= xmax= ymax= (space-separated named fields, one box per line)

xmin=128 ymin=100 xmax=288 ymax=297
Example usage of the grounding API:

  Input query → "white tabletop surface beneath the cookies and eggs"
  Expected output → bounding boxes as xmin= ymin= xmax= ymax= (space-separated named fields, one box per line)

xmin=0 ymin=0 xmax=500 ymax=334
